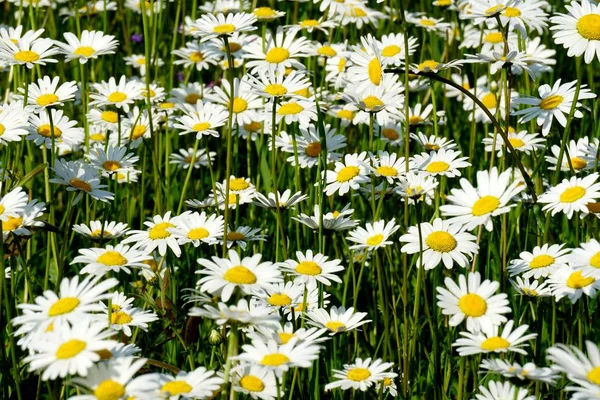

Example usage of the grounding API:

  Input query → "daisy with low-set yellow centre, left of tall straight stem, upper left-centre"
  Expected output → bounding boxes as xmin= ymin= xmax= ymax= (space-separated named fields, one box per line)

xmin=174 ymin=101 xmax=229 ymax=139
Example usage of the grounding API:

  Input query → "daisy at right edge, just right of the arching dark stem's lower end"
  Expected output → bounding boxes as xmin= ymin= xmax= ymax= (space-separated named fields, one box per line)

xmin=538 ymin=173 xmax=600 ymax=219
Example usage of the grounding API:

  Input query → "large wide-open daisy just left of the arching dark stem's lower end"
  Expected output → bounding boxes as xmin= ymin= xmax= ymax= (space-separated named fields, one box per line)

xmin=440 ymin=167 xmax=524 ymax=232
